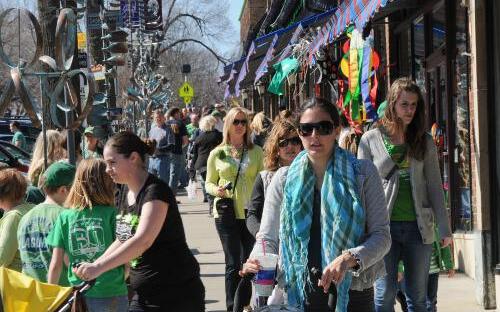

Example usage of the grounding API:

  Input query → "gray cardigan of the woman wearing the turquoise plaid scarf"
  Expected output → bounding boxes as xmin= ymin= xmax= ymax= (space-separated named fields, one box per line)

xmin=250 ymin=160 xmax=391 ymax=291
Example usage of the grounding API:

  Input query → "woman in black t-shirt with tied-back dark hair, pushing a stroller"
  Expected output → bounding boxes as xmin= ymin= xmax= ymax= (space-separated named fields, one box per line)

xmin=75 ymin=132 xmax=205 ymax=312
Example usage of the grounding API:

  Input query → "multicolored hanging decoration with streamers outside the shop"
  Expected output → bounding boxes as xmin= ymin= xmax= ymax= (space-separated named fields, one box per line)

xmin=338 ymin=28 xmax=380 ymax=129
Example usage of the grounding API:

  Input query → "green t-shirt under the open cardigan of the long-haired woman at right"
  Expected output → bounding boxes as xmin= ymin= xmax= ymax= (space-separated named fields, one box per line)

xmin=384 ymin=135 xmax=417 ymax=221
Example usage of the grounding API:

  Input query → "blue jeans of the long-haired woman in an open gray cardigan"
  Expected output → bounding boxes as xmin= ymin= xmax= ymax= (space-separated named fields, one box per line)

xmin=375 ymin=222 xmax=432 ymax=312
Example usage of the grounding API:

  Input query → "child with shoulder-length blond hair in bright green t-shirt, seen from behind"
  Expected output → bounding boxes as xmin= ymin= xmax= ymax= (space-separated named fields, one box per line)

xmin=46 ymin=159 xmax=128 ymax=312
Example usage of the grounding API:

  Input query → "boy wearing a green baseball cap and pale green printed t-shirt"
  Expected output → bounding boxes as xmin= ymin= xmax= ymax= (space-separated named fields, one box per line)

xmin=17 ymin=161 xmax=76 ymax=286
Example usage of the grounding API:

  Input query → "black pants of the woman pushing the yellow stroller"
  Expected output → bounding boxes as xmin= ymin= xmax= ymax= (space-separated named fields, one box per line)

xmin=128 ymin=277 xmax=205 ymax=312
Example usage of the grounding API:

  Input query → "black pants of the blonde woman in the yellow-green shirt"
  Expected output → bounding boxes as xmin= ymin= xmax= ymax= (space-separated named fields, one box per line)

xmin=215 ymin=219 xmax=255 ymax=311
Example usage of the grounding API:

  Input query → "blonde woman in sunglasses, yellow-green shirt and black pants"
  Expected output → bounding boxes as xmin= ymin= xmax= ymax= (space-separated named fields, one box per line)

xmin=205 ymin=107 xmax=263 ymax=311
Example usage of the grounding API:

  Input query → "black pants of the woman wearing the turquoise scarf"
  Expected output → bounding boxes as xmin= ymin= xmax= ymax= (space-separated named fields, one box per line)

xmin=305 ymin=281 xmax=375 ymax=312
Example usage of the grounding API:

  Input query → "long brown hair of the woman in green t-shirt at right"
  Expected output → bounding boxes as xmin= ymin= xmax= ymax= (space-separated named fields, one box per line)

xmin=381 ymin=77 xmax=427 ymax=160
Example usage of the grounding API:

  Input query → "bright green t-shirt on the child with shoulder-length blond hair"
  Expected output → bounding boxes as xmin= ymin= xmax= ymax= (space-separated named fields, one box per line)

xmin=46 ymin=206 xmax=127 ymax=298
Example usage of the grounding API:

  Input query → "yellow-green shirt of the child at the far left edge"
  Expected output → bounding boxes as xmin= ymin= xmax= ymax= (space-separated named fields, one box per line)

xmin=0 ymin=203 xmax=33 ymax=272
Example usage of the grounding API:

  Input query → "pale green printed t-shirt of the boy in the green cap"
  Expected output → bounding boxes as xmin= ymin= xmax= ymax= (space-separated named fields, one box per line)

xmin=17 ymin=203 xmax=70 ymax=286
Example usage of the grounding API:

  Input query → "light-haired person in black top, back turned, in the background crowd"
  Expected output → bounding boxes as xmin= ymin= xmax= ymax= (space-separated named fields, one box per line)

xmin=189 ymin=115 xmax=222 ymax=207
